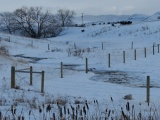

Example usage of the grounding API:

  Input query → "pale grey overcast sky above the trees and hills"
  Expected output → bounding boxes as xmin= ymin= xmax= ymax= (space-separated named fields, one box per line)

xmin=0 ymin=0 xmax=160 ymax=16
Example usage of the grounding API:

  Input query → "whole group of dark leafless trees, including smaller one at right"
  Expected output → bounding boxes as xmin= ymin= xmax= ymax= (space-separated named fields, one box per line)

xmin=0 ymin=7 xmax=75 ymax=38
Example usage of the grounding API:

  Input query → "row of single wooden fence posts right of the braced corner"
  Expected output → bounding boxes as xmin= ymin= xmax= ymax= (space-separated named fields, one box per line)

xmin=61 ymin=43 xmax=159 ymax=103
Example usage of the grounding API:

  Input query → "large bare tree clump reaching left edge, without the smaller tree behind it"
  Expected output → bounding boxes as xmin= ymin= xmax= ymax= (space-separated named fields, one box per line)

xmin=1 ymin=7 xmax=62 ymax=38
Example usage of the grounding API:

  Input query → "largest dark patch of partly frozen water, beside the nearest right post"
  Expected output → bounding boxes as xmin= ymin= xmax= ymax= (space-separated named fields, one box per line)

xmin=91 ymin=71 xmax=160 ymax=88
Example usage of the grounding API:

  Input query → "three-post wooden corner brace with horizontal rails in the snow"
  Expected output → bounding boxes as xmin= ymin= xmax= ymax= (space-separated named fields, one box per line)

xmin=11 ymin=66 xmax=44 ymax=93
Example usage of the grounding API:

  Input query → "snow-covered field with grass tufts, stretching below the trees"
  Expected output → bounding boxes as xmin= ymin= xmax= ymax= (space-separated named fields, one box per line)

xmin=0 ymin=21 xmax=160 ymax=120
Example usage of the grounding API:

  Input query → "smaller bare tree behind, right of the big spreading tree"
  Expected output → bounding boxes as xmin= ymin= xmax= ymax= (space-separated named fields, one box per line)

xmin=57 ymin=9 xmax=76 ymax=27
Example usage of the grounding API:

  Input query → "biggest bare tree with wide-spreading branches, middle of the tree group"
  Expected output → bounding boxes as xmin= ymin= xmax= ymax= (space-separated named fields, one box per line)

xmin=14 ymin=7 xmax=62 ymax=38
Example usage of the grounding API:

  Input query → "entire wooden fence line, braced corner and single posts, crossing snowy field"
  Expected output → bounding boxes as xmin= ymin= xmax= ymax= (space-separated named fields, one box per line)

xmin=11 ymin=43 xmax=159 ymax=102
